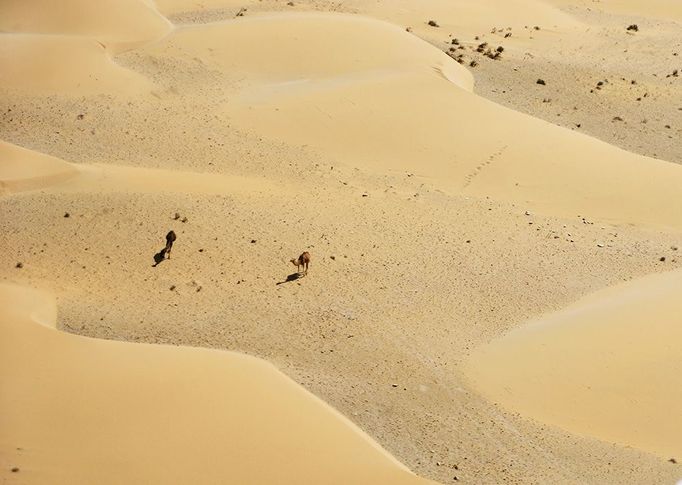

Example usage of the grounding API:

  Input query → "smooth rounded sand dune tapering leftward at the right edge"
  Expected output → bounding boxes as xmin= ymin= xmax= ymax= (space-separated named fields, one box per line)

xmin=468 ymin=271 xmax=682 ymax=459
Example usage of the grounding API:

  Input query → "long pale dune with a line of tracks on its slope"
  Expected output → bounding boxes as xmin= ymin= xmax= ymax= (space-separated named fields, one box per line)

xmin=135 ymin=14 xmax=682 ymax=228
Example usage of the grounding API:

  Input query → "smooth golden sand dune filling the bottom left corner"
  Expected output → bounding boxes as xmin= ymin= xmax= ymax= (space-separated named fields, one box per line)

xmin=0 ymin=284 xmax=428 ymax=484
